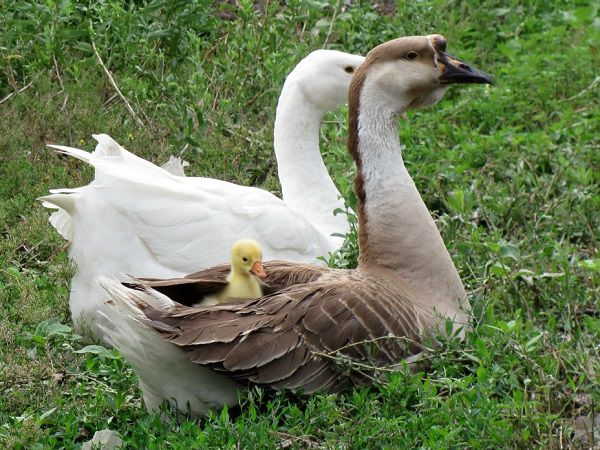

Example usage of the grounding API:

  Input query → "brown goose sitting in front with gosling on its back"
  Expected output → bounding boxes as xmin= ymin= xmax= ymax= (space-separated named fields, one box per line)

xmin=101 ymin=35 xmax=491 ymax=414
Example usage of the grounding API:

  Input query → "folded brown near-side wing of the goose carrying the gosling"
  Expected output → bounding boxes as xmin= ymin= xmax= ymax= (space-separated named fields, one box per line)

xmin=139 ymin=272 xmax=423 ymax=394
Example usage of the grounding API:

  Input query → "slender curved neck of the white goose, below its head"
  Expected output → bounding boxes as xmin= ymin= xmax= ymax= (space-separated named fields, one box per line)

xmin=274 ymin=80 xmax=349 ymax=250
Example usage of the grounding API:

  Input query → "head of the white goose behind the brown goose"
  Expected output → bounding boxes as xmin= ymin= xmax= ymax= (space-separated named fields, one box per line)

xmin=287 ymin=50 xmax=365 ymax=112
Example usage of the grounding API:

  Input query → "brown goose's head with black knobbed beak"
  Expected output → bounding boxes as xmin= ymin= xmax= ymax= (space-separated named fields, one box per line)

xmin=350 ymin=34 xmax=492 ymax=115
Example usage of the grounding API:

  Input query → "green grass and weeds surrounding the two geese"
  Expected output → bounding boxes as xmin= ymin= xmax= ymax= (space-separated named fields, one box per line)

xmin=0 ymin=0 xmax=600 ymax=449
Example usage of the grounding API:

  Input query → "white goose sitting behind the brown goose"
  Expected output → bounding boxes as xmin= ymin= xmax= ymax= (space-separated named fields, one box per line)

xmin=40 ymin=50 xmax=364 ymax=339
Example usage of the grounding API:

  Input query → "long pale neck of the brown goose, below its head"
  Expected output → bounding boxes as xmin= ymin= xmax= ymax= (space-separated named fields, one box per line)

xmin=351 ymin=85 xmax=466 ymax=317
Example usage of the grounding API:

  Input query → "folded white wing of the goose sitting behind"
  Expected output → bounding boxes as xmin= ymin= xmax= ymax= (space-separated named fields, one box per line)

xmin=45 ymin=135 xmax=334 ymax=273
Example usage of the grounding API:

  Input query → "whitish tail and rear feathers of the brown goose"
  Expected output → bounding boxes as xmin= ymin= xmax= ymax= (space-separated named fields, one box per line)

xmin=98 ymin=277 xmax=239 ymax=416
